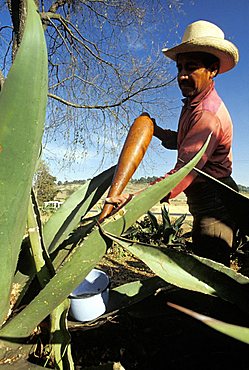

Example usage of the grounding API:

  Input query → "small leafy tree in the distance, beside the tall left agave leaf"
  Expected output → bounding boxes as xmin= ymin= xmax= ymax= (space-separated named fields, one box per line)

xmin=34 ymin=161 xmax=58 ymax=205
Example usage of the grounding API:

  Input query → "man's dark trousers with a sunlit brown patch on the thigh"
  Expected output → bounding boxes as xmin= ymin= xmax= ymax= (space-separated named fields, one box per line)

xmin=185 ymin=177 xmax=238 ymax=266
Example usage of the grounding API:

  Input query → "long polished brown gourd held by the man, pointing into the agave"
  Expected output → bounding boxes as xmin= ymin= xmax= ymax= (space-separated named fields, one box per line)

xmin=99 ymin=113 xmax=154 ymax=222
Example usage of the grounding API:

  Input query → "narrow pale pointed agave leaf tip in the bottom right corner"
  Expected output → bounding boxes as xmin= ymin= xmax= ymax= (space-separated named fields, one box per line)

xmin=168 ymin=302 xmax=249 ymax=344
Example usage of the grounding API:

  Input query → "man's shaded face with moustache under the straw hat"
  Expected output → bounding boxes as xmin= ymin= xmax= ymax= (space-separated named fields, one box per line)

xmin=177 ymin=53 xmax=216 ymax=97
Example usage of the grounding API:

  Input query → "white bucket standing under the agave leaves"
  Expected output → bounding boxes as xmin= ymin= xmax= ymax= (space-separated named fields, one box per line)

xmin=69 ymin=269 xmax=110 ymax=321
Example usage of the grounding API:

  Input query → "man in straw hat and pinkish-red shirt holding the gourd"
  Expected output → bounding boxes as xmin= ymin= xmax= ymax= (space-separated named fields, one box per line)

xmin=107 ymin=21 xmax=239 ymax=266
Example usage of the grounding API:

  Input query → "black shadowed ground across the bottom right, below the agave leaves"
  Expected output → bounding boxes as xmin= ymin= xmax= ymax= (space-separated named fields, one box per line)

xmin=71 ymin=290 xmax=249 ymax=370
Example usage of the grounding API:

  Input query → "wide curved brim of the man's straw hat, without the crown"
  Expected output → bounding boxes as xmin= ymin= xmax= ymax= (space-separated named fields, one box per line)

xmin=162 ymin=37 xmax=239 ymax=73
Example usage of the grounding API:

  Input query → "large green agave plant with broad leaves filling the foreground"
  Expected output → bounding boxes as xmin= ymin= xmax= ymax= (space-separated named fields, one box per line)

xmin=0 ymin=0 xmax=249 ymax=369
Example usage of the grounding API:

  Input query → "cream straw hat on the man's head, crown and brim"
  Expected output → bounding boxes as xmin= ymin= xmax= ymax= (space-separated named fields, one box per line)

xmin=162 ymin=21 xmax=239 ymax=73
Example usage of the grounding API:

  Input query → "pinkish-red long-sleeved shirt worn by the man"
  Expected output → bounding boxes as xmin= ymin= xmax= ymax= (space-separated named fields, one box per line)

xmin=158 ymin=82 xmax=233 ymax=198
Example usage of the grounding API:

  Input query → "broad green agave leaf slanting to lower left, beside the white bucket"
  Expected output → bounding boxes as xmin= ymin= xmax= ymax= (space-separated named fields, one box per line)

xmin=0 ymin=229 xmax=106 ymax=340
